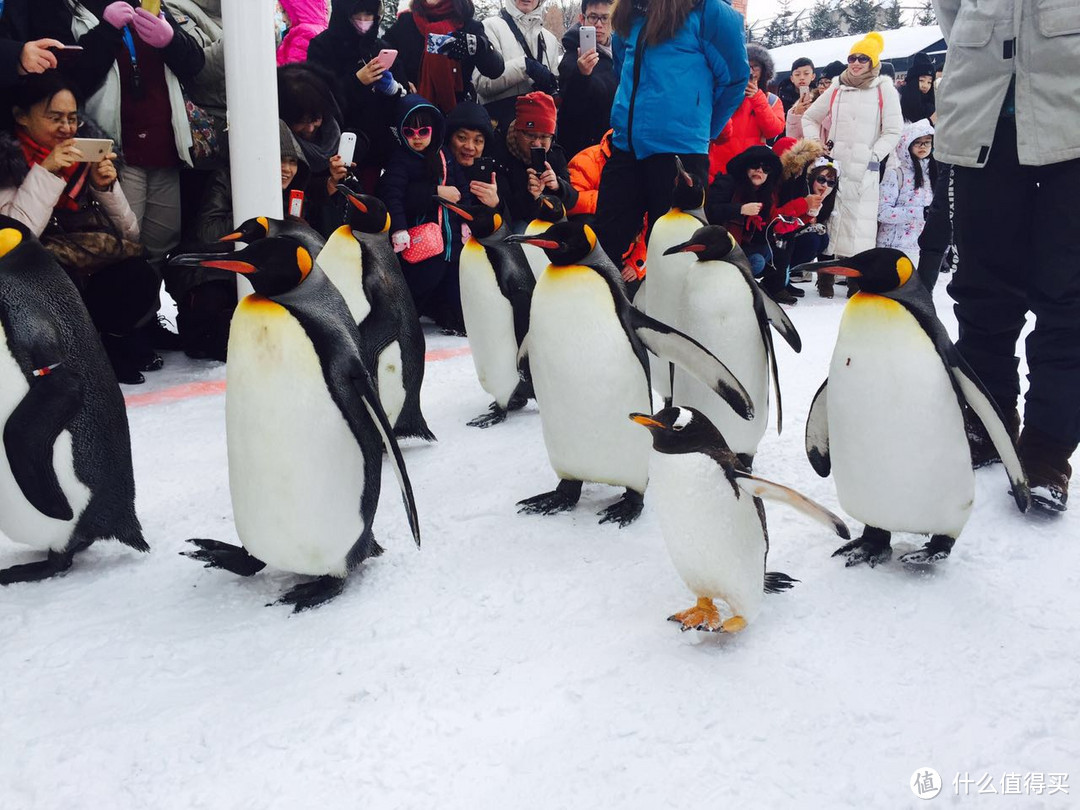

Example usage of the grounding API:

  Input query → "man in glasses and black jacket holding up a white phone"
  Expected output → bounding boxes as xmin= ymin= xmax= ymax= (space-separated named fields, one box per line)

xmin=558 ymin=0 xmax=619 ymax=159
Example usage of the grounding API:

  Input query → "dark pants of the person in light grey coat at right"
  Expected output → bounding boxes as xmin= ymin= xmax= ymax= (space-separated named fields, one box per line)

xmin=948 ymin=118 xmax=1080 ymax=443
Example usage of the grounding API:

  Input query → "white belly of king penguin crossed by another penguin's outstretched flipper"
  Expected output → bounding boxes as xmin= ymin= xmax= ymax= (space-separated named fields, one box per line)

xmin=674 ymin=261 xmax=769 ymax=455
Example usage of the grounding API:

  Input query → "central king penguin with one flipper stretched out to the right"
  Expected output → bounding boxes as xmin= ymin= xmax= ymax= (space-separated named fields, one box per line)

xmin=508 ymin=221 xmax=754 ymax=526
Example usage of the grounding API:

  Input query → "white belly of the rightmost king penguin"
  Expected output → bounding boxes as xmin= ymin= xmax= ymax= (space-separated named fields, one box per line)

xmin=827 ymin=293 xmax=974 ymax=538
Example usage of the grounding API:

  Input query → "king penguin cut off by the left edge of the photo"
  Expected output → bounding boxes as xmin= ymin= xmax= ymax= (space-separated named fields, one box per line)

xmin=0 ymin=216 xmax=150 ymax=585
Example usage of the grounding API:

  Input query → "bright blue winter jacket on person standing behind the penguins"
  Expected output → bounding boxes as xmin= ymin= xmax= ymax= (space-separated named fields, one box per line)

xmin=611 ymin=0 xmax=750 ymax=159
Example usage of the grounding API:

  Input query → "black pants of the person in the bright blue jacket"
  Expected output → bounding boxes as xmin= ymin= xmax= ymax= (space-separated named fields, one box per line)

xmin=596 ymin=152 xmax=708 ymax=269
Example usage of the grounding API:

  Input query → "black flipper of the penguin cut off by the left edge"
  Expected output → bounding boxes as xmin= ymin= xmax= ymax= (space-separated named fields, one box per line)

xmin=3 ymin=365 xmax=82 ymax=521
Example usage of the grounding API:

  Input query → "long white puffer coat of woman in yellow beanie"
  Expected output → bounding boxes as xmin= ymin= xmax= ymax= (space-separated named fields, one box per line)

xmin=802 ymin=76 xmax=904 ymax=256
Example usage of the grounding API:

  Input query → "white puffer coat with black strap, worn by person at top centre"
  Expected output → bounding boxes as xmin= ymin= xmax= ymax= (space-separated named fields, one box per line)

xmin=473 ymin=0 xmax=563 ymax=104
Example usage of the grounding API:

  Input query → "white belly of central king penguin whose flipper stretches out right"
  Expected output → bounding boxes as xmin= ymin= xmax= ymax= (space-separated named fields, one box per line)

xmin=529 ymin=267 xmax=651 ymax=492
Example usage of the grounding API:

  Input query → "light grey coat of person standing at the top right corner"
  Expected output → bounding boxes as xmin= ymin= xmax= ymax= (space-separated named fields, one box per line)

xmin=934 ymin=0 xmax=1080 ymax=168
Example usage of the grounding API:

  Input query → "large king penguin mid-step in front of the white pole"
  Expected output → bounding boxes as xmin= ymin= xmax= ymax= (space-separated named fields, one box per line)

xmin=174 ymin=237 xmax=420 ymax=610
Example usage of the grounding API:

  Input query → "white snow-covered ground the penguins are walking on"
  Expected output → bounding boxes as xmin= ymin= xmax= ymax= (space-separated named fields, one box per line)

xmin=0 ymin=279 xmax=1080 ymax=810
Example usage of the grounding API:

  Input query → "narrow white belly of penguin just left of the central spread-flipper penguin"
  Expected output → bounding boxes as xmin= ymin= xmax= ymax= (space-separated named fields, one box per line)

xmin=459 ymin=239 xmax=521 ymax=408
